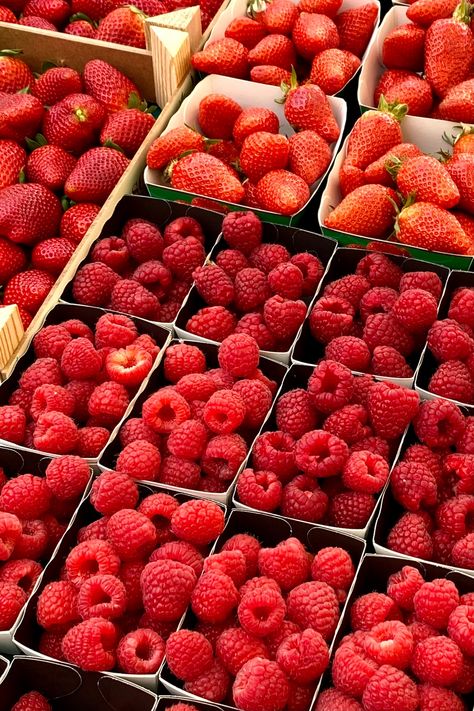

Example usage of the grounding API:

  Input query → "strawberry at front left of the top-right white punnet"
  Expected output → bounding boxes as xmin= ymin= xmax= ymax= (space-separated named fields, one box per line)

xmin=374 ymin=69 xmax=433 ymax=116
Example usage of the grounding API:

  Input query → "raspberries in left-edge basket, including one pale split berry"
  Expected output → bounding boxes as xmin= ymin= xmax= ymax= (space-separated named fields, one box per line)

xmin=0 ymin=313 xmax=160 ymax=458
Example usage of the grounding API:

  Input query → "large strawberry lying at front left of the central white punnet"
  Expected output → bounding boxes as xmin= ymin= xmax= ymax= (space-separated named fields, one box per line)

xmin=171 ymin=153 xmax=244 ymax=203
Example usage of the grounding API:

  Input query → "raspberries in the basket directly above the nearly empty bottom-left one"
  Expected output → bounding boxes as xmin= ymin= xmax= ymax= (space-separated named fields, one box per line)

xmin=36 ymin=486 xmax=224 ymax=674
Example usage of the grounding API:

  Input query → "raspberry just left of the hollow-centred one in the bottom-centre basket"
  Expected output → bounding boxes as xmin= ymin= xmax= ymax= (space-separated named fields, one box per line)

xmin=191 ymin=571 xmax=239 ymax=622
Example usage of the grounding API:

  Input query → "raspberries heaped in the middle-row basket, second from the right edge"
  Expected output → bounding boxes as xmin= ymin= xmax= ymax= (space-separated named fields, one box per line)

xmin=236 ymin=360 xmax=419 ymax=528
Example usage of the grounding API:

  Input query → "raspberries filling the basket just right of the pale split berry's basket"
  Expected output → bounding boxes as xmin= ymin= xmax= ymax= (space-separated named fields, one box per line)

xmin=106 ymin=333 xmax=277 ymax=492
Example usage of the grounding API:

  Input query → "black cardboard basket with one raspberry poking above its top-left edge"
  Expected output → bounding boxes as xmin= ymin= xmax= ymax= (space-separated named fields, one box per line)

xmin=174 ymin=227 xmax=337 ymax=364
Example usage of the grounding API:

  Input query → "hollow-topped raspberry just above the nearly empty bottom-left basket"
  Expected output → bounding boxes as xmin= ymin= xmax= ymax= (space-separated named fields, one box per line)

xmin=117 ymin=628 xmax=165 ymax=674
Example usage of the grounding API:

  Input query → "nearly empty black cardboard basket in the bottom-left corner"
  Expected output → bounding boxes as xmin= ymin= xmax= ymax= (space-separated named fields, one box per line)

xmin=0 ymin=656 xmax=157 ymax=711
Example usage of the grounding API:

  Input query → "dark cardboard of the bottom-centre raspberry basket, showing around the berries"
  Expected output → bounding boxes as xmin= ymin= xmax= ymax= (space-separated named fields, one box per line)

xmin=160 ymin=509 xmax=366 ymax=708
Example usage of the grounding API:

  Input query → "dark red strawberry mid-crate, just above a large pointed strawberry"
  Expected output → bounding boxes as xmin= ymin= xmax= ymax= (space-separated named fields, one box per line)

xmin=43 ymin=94 xmax=106 ymax=153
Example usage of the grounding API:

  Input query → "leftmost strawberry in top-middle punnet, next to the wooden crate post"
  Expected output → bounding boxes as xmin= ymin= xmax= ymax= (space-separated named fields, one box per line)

xmin=191 ymin=37 xmax=250 ymax=79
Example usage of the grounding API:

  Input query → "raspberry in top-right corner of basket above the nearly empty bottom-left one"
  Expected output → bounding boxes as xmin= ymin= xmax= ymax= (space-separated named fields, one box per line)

xmin=171 ymin=499 xmax=224 ymax=546
